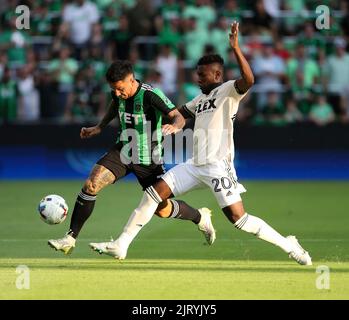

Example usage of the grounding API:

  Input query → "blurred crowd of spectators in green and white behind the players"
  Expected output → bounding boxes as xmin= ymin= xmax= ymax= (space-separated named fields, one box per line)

xmin=0 ymin=0 xmax=349 ymax=126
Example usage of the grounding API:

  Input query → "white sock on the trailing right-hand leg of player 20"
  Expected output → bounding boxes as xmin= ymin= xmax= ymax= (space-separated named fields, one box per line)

xmin=234 ymin=213 xmax=293 ymax=253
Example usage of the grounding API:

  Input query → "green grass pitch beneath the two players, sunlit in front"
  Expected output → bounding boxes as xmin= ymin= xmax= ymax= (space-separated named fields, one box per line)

xmin=0 ymin=181 xmax=349 ymax=300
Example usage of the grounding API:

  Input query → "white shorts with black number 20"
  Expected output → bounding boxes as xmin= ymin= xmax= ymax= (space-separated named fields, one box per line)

xmin=161 ymin=159 xmax=246 ymax=208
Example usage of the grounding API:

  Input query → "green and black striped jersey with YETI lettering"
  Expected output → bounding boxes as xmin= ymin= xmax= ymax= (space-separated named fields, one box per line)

xmin=111 ymin=83 xmax=175 ymax=165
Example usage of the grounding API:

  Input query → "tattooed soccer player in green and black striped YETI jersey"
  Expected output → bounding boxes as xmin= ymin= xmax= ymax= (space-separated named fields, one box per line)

xmin=48 ymin=60 xmax=216 ymax=254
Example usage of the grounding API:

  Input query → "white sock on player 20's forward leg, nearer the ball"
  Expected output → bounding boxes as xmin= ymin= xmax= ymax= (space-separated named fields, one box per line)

xmin=116 ymin=186 xmax=162 ymax=249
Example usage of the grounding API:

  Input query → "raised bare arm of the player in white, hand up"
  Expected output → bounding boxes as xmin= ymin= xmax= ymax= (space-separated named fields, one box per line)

xmin=229 ymin=21 xmax=254 ymax=94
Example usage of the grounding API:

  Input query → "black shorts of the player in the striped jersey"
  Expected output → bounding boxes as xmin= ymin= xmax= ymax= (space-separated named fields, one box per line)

xmin=97 ymin=144 xmax=165 ymax=190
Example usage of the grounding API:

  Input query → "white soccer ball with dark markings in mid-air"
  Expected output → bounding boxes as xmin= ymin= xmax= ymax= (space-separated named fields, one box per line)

xmin=38 ymin=194 xmax=68 ymax=224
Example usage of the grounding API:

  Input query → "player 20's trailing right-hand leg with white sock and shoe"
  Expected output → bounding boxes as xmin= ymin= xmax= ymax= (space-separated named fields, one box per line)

xmin=222 ymin=201 xmax=312 ymax=265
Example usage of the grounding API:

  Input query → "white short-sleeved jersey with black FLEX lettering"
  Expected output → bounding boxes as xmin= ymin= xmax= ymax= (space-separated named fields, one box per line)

xmin=184 ymin=80 xmax=245 ymax=166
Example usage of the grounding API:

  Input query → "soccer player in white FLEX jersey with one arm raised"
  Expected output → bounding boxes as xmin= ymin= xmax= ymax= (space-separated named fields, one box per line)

xmin=90 ymin=22 xmax=312 ymax=265
